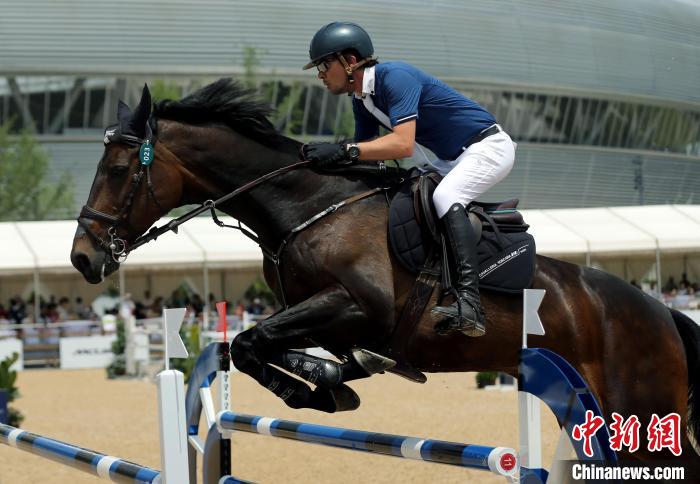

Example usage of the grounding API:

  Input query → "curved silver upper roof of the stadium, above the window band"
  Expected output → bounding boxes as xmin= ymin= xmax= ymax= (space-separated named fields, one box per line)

xmin=0 ymin=0 xmax=700 ymax=108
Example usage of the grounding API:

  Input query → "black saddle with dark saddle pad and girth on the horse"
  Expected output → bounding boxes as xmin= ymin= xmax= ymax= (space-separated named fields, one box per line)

xmin=384 ymin=172 xmax=535 ymax=383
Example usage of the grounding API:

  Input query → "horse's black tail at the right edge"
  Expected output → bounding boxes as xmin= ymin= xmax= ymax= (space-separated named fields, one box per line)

xmin=671 ymin=309 xmax=700 ymax=442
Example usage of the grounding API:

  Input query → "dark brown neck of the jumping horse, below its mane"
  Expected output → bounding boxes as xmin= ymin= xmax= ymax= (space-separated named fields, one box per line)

xmin=168 ymin=128 xmax=355 ymax=247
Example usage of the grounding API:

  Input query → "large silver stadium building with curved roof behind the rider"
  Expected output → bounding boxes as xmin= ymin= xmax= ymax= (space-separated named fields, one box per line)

xmin=0 ymin=0 xmax=700 ymax=218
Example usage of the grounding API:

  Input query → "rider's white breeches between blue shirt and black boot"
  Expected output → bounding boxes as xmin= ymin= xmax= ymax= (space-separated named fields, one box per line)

xmin=433 ymin=131 xmax=516 ymax=218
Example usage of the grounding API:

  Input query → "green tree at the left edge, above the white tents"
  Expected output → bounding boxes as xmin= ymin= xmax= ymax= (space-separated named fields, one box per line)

xmin=0 ymin=121 xmax=75 ymax=221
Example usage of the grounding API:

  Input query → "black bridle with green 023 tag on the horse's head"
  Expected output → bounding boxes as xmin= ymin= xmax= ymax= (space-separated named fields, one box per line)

xmin=78 ymin=116 xmax=163 ymax=263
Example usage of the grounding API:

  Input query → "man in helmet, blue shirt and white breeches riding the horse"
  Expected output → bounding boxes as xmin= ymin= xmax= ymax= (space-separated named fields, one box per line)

xmin=303 ymin=22 xmax=515 ymax=336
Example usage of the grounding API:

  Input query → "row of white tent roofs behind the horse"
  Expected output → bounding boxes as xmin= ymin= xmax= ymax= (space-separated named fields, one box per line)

xmin=0 ymin=205 xmax=700 ymax=274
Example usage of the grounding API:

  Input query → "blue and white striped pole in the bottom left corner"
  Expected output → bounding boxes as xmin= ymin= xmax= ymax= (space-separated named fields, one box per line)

xmin=0 ymin=424 xmax=161 ymax=484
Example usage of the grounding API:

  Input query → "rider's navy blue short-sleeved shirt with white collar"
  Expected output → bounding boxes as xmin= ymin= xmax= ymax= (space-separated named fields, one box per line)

xmin=352 ymin=62 xmax=496 ymax=160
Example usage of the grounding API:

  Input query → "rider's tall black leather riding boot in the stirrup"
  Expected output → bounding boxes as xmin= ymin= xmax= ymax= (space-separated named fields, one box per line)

xmin=431 ymin=203 xmax=486 ymax=336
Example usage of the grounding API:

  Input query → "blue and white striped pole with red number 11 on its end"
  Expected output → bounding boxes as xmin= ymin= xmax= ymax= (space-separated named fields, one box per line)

xmin=216 ymin=411 xmax=520 ymax=478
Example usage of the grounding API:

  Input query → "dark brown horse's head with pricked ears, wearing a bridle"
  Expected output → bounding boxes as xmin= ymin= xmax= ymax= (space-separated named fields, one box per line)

xmin=71 ymin=86 xmax=182 ymax=284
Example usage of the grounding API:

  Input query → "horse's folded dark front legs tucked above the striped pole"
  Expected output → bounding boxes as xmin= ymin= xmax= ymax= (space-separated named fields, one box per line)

xmin=231 ymin=285 xmax=392 ymax=412
